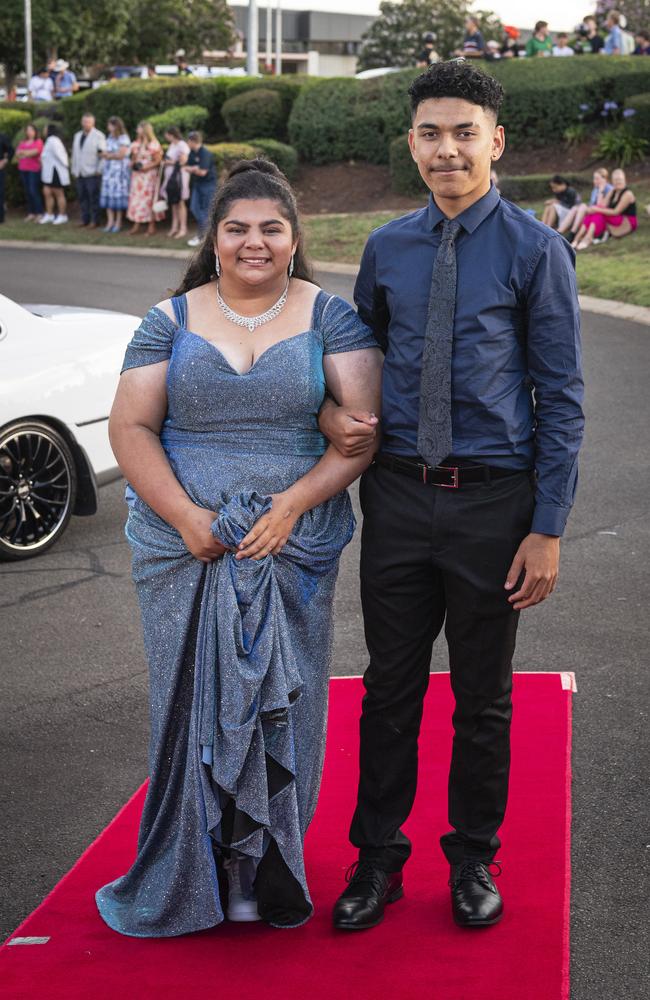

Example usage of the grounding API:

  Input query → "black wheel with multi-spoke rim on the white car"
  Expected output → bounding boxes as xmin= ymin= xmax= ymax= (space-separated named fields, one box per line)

xmin=0 ymin=420 xmax=77 ymax=560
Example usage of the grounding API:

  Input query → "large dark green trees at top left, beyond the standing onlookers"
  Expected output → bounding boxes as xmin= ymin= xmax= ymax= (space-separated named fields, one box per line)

xmin=0 ymin=0 xmax=234 ymax=89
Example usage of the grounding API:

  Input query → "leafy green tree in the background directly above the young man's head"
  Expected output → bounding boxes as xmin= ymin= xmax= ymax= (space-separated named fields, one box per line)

xmin=358 ymin=0 xmax=501 ymax=70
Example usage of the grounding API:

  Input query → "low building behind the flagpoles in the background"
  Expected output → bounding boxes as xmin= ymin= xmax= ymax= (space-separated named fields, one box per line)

xmin=230 ymin=3 xmax=375 ymax=76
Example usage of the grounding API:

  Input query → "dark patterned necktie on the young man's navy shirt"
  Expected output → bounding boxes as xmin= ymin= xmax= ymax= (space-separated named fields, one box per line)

xmin=418 ymin=219 xmax=461 ymax=466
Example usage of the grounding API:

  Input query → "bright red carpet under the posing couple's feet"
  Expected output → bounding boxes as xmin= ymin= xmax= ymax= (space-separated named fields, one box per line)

xmin=0 ymin=673 xmax=571 ymax=1000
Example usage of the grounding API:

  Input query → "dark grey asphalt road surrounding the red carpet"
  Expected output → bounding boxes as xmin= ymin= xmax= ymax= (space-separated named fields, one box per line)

xmin=0 ymin=245 xmax=650 ymax=1000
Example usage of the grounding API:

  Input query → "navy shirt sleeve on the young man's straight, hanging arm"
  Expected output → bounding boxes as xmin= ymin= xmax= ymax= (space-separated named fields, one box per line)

xmin=526 ymin=236 xmax=584 ymax=536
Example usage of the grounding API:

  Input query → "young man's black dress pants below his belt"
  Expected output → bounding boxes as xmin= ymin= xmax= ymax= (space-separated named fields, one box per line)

xmin=350 ymin=462 xmax=534 ymax=871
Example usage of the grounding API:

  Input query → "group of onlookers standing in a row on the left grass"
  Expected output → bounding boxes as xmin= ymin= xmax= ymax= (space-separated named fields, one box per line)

xmin=0 ymin=112 xmax=217 ymax=246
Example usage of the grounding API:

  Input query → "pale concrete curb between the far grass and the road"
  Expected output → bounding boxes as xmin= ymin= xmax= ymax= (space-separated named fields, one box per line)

xmin=0 ymin=239 xmax=650 ymax=326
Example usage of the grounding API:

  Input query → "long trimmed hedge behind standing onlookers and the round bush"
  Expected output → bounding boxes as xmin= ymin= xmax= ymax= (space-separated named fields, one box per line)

xmin=57 ymin=76 xmax=303 ymax=145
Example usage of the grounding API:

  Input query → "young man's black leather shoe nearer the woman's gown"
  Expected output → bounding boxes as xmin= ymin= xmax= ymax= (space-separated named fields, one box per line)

xmin=334 ymin=861 xmax=404 ymax=931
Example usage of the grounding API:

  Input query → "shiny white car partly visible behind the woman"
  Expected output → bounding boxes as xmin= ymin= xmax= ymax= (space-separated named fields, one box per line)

xmin=0 ymin=295 xmax=140 ymax=559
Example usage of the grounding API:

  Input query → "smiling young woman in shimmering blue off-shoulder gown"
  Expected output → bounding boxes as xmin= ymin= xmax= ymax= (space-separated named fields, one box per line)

xmin=96 ymin=160 xmax=381 ymax=937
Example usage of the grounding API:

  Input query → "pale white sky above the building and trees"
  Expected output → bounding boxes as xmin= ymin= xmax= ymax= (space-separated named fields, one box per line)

xmin=251 ymin=0 xmax=596 ymax=31
